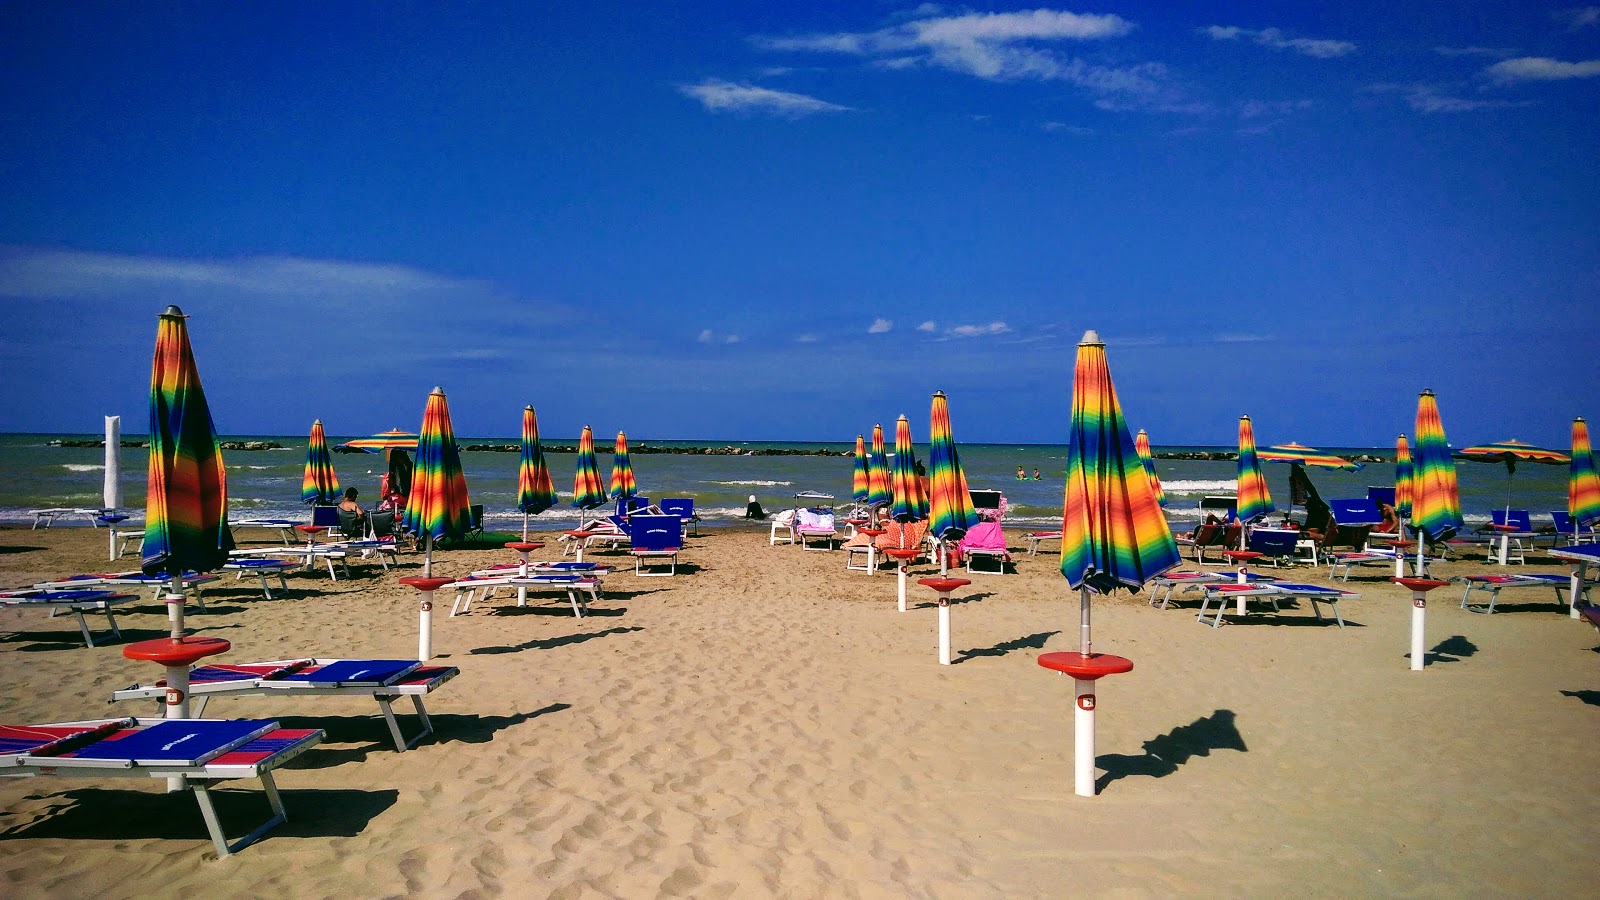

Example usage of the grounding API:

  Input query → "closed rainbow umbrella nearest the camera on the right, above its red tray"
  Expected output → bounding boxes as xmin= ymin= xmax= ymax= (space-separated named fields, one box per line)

xmin=1061 ymin=331 xmax=1179 ymax=595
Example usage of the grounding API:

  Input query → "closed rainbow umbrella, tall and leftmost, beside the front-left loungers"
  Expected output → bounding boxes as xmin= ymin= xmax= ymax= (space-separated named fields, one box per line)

xmin=139 ymin=306 xmax=234 ymax=641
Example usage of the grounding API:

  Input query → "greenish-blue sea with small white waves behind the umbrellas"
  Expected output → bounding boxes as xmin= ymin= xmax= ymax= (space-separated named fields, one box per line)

xmin=0 ymin=434 xmax=1566 ymax=530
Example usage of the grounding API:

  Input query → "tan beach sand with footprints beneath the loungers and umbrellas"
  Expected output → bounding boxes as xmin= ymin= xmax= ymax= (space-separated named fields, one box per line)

xmin=0 ymin=528 xmax=1600 ymax=897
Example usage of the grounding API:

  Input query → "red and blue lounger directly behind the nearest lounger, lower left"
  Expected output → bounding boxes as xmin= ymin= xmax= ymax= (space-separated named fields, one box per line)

xmin=110 ymin=660 xmax=461 ymax=753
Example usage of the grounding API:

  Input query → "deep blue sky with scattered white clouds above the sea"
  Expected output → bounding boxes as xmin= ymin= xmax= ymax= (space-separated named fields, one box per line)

xmin=0 ymin=2 xmax=1600 ymax=447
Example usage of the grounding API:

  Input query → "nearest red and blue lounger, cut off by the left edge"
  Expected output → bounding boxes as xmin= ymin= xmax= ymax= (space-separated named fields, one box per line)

xmin=0 ymin=719 xmax=323 ymax=857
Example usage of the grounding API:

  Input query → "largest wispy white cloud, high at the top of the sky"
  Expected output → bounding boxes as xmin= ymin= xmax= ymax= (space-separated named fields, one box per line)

xmin=755 ymin=10 xmax=1170 ymax=106
